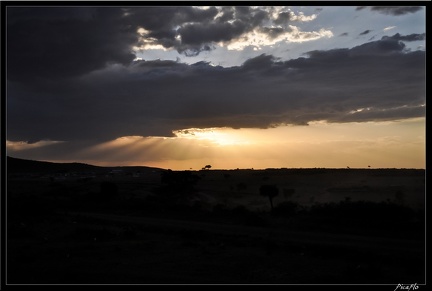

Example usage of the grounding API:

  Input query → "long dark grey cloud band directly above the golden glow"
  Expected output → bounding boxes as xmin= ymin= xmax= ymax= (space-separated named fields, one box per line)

xmin=7 ymin=36 xmax=426 ymax=142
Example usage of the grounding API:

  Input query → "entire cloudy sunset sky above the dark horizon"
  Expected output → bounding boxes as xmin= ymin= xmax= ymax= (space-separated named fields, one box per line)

xmin=4 ymin=2 xmax=426 ymax=170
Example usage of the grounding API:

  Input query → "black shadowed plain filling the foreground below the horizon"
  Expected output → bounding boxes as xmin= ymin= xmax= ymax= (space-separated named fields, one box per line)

xmin=6 ymin=169 xmax=425 ymax=290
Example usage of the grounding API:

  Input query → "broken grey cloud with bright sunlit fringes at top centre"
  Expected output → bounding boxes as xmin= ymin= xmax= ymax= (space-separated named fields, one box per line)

xmin=128 ymin=6 xmax=322 ymax=56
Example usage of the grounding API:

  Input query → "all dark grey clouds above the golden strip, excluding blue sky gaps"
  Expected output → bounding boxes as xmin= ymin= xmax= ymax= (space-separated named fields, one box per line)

xmin=7 ymin=7 xmax=426 ymax=143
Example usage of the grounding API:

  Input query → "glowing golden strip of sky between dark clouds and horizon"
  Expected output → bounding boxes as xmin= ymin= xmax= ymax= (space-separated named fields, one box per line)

xmin=7 ymin=118 xmax=426 ymax=170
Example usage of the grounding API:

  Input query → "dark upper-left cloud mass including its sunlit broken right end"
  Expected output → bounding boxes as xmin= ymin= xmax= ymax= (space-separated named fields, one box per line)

xmin=7 ymin=6 xmax=318 ymax=82
